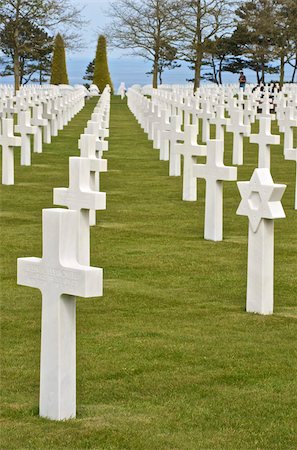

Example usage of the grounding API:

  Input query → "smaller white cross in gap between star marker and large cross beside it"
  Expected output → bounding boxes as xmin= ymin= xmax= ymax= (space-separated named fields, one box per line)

xmin=227 ymin=108 xmax=251 ymax=165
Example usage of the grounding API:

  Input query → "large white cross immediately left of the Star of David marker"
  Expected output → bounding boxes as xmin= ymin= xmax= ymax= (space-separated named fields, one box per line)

xmin=193 ymin=139 xmax=237 ymax=241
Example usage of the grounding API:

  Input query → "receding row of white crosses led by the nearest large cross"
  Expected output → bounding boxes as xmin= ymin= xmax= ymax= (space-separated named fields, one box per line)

xmin=17 ymin=87 xmax=110 ymax=420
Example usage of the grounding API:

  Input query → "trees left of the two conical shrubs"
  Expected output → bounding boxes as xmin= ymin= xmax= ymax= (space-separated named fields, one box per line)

xmin=0 ymin=0 xmax=84 ymax=90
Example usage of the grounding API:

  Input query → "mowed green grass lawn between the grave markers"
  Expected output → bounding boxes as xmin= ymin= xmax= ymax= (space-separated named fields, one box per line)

xmin=0 ymin=97 xmax=297 ymax=450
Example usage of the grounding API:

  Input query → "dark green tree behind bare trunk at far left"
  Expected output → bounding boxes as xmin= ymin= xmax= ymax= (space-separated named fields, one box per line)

xmin=0 ymin=20 xmax=53 ymax=84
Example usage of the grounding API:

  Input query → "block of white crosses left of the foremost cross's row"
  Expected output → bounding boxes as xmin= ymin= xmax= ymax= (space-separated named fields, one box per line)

xmin=0 ymin=86 xmax=85 ymax=185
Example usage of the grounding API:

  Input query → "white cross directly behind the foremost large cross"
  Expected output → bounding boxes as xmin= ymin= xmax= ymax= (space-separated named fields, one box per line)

xmin=54 ymin=157 xmax=106 ymax=265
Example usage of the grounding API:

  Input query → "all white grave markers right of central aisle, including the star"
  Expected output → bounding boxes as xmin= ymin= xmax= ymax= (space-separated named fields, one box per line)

xmin=128 ymin=88 xmax=296 ymax=314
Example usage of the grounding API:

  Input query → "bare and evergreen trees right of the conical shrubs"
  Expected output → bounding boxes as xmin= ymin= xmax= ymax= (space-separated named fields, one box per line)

xmin=106 ymin=0 xmax=297 ymax=90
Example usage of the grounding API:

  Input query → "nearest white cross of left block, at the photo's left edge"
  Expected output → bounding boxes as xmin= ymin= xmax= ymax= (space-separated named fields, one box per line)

xmin=0 ymin=119 xmax=21 ymax=185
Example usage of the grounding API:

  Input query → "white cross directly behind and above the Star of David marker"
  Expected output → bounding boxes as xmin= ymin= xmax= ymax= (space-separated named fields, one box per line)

xmin=250 ymin=117 xmax=280 ymax=169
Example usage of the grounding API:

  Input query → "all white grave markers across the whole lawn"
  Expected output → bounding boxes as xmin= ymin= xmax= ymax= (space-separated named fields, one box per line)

xmin=0 ymin=80 xmax=297 ymax=420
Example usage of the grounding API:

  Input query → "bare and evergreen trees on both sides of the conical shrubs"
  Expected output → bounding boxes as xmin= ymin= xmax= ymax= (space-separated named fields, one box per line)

xmin=0 ymin=0 xmax=297 ymax=89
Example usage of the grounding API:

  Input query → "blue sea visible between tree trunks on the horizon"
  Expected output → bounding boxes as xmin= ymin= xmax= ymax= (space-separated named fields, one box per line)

xmin=0 ymin=55 xmax=290 ymax=89
